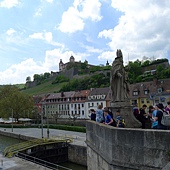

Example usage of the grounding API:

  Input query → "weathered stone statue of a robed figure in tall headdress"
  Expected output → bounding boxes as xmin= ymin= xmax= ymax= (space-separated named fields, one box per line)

xmin=110 ymin=50 xmax=129 ymax=102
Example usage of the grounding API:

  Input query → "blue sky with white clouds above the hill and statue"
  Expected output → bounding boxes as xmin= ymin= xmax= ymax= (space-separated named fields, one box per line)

xmin=0 ymin=0 xmax=170 ymax=85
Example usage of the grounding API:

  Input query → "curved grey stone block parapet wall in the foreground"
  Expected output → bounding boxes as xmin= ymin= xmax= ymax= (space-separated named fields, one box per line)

xmin=86 ymin=121 xmax=170 ymax=170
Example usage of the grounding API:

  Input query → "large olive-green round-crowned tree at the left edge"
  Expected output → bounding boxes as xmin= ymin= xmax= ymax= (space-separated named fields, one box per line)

xmin=0 ymin=85 xmax=34 ymax=121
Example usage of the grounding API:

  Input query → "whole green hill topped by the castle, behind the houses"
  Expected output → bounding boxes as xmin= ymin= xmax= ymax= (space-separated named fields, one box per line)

xmin=23 ymin=56 xmax=170 ymax=94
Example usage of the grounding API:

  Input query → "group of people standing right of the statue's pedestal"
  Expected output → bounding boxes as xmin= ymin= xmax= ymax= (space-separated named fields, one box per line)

xmin=133 ymin=101 xmax=170 ymax=130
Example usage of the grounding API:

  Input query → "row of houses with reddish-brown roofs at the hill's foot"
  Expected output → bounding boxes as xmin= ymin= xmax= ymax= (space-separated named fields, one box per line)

xmin=34 ymin=79 xmax=170 ymax=119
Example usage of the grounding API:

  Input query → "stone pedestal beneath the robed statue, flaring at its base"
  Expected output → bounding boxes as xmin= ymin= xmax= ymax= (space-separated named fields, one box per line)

xmin=110 ymin=101 xmax=141 ymax=128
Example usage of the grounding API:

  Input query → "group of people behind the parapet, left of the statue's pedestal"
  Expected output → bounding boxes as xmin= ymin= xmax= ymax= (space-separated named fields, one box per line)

xmin=90 ymin=105 xmax=125 ymax=127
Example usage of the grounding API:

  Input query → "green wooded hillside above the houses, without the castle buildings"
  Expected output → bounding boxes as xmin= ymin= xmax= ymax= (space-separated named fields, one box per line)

xmin=18 ymin=59 xmax=170 ymax=95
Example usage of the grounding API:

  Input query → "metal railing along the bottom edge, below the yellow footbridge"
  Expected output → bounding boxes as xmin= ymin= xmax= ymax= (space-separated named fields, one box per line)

xmin=15 ymin=152 xmax=72 ymax=170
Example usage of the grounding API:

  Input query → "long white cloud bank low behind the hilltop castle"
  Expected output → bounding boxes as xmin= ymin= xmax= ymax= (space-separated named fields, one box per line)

xmin=0 ymin=49 xmax=85 ymax=85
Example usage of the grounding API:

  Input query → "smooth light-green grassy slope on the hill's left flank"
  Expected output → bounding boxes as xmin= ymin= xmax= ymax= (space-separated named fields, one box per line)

xmin=22 ymin=80 xmax=65 ymax=95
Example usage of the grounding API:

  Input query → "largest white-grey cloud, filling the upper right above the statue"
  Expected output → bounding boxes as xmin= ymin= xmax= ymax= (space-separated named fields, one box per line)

xmin=98 ymin=0 xmax=170 ymax=60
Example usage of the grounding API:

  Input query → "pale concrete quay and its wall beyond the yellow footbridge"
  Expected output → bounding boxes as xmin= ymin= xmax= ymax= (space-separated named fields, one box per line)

xmin=0 ymin=128 xmax=87 ymax=166
